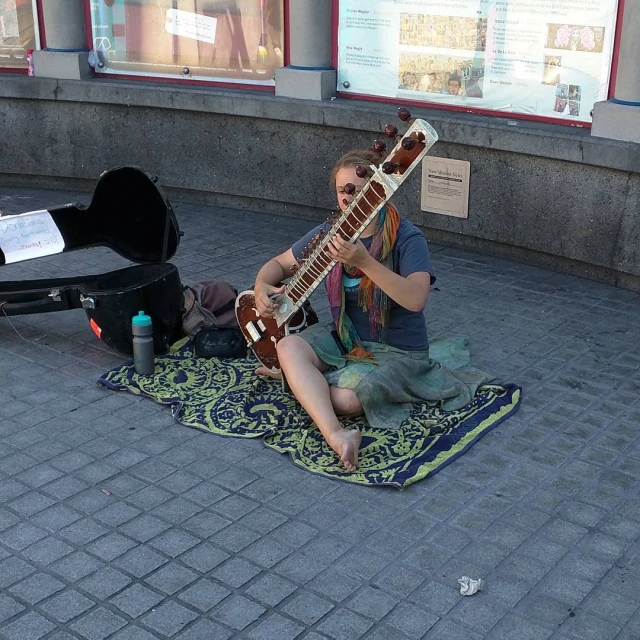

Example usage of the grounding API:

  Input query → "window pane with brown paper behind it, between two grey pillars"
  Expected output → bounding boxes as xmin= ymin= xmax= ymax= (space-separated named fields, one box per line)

xmin=91 ymin=0 xmax=284 ymax=84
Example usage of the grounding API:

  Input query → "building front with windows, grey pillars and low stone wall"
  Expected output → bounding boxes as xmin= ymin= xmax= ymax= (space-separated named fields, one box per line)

xmin=0 ymin=0 xmax=640 ymax=289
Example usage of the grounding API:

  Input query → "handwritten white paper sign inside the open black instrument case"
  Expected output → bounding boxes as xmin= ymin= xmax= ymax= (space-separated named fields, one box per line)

xmin=0 ymin=210 xmax=64 ymax=264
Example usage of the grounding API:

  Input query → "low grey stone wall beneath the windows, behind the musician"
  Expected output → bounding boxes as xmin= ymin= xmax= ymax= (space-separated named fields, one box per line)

xmin=0 ymin=76 xmax=640 ymax=289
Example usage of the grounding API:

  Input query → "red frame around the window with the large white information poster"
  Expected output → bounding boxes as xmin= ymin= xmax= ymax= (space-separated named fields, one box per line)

xmin=331 ymin=0 xmax=625 ymax=129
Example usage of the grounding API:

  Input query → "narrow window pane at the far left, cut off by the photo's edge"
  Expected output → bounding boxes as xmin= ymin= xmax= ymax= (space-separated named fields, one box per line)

xmin=0 ymin=0 xmax=36 ymax=69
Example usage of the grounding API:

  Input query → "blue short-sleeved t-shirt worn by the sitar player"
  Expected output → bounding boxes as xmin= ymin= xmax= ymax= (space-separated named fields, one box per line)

xmin=291 ymin=219 xmax=435 ymax=351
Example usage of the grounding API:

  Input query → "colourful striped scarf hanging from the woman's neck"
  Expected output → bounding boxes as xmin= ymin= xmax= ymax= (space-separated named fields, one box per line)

xmin=327 ymin=204 xmax=400 ymax=360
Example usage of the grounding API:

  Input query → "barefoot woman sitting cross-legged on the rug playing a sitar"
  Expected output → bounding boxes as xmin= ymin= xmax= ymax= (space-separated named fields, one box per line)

xmin=254 ymin=150 xmax=432 ymax=471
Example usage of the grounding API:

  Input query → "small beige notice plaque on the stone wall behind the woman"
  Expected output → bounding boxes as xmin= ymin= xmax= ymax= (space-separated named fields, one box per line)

xmin=420 ymin=156 xmax=471 ymax=218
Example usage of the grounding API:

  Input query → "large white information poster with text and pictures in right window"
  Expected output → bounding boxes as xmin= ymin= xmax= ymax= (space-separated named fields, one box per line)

xmin=338 ymin=0 xmax=618 ymax=122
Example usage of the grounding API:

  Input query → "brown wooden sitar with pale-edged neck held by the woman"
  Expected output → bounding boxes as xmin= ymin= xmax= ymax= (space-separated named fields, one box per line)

xmin=236 ymin=107 xmax=438 ymax=373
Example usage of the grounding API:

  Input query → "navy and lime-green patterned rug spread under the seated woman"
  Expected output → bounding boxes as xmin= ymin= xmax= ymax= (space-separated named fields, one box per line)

xmin=98 ymin=342 xmax=521 ymax=488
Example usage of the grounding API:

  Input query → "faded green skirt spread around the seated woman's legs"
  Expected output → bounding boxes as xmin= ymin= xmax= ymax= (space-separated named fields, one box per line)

xmin=297 ymin=324 xmax=493 ymax=429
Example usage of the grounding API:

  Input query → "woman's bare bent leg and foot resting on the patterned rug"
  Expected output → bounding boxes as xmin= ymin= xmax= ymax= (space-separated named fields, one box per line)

xmin=278 ymin=336 xmax=362 ymax=471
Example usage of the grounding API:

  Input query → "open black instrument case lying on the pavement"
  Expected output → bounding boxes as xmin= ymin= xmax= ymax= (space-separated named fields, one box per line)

xmin=0 ymin=166 xmax=183 ymax=354
